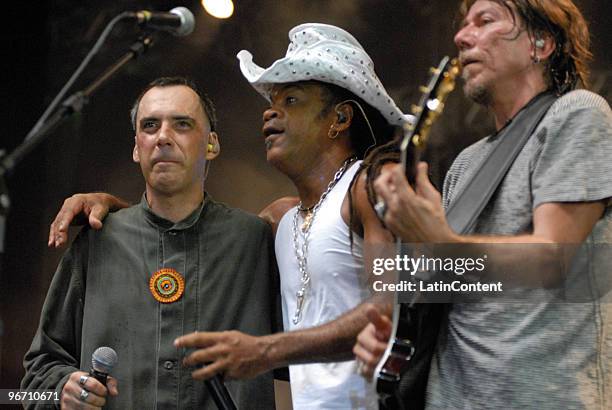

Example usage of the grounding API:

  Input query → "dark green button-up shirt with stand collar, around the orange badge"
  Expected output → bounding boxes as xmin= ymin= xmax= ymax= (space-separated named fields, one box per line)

xmin=22 ymin=197 xmax=278 ymax=409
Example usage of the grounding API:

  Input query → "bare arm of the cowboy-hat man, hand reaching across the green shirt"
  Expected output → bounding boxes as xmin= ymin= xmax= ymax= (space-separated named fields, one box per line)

xmin=175 ymin=171 xmax=392 ymax=379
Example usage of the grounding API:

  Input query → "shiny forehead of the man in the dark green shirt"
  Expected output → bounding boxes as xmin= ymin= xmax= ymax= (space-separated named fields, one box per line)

xmin=137 ymin=85 xmax=208 ymax=124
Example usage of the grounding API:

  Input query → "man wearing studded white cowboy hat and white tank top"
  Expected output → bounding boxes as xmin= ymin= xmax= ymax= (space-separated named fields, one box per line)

xmin=51 ymin=24 xmax=407 ymax=409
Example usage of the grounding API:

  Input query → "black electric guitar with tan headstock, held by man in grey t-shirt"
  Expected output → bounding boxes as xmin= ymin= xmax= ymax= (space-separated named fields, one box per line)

xmin=374 ymin=57 xmax=459 ymax=410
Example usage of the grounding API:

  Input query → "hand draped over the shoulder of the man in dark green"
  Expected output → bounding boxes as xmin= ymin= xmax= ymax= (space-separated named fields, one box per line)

xmin=47 ymin=192 xmax=130 ymax=248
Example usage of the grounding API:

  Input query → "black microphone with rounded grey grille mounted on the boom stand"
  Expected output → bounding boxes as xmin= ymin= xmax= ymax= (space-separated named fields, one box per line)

xmin=128 ymin=7 xmax=195 ymax=37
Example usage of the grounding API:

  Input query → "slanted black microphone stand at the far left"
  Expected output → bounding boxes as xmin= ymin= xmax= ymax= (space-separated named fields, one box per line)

xmin=0 ymin=33 xmax=153 ymax=262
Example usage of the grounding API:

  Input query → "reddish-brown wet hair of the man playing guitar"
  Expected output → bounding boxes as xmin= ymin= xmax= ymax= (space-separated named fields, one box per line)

xmin=459 ymin=0 xmax=592 ymax=94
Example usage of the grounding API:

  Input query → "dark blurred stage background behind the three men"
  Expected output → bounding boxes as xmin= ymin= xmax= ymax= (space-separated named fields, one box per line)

xmin=0 ymin=0 xmax=612 ymax=396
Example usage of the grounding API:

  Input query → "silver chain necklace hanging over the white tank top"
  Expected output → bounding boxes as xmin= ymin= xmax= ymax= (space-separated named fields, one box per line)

xmin=292 ymin=157 xmax=357 ymax=325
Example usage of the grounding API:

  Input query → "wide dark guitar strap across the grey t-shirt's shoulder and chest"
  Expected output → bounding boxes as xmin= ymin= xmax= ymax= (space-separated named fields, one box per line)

xmin=446 ymin=92 xmax=557 ymax=234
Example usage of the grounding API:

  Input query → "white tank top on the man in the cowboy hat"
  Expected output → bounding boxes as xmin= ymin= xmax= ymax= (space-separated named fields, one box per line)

xmin=275 ymin=161 xmax=378 ymax=410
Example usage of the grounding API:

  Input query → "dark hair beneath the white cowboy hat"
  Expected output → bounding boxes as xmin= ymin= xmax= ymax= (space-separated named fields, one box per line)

xmin=315 ymin=81 xmax=393 ymax=159
